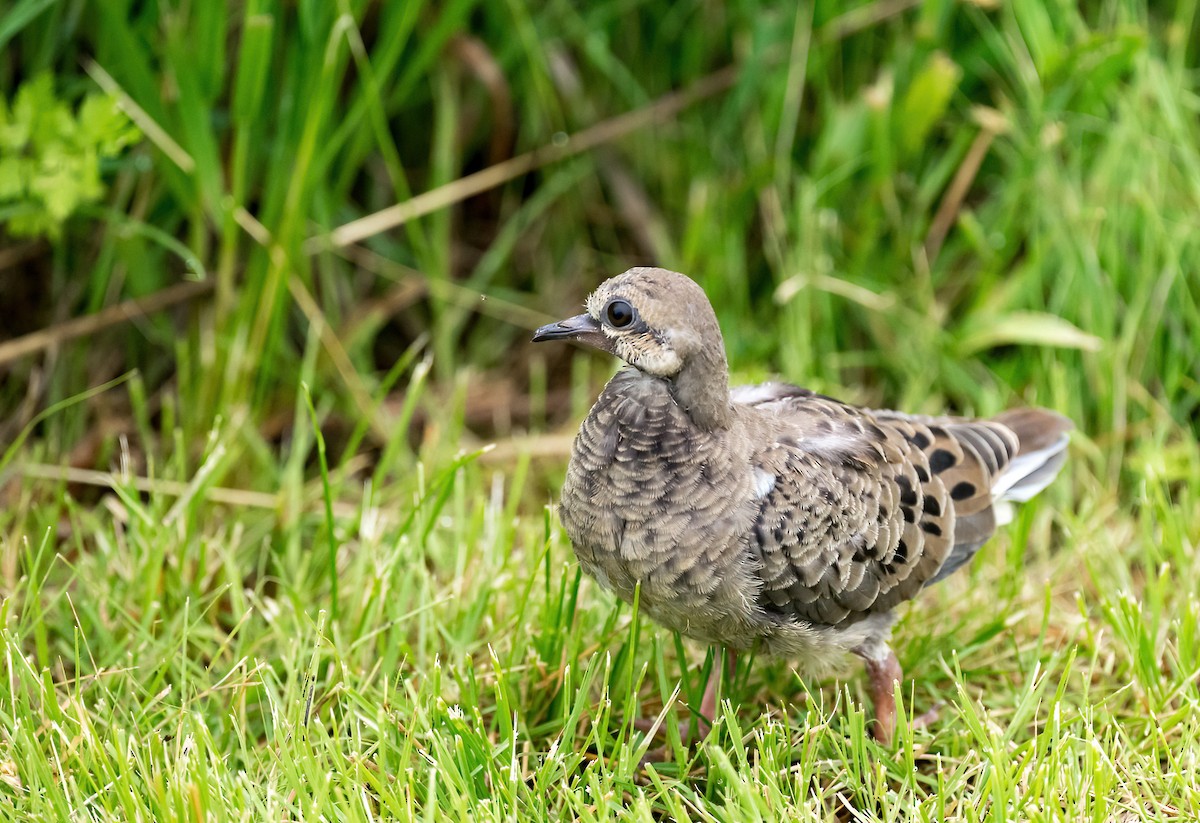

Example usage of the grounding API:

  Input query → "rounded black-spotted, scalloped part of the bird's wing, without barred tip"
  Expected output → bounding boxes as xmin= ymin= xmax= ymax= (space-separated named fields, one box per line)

xmin=734 ymin=385 xmax=962 ymax=625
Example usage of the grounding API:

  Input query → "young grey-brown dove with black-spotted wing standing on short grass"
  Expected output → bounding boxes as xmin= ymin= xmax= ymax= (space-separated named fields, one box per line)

xmin=533 ymin=268 xmax=1073 ymax=745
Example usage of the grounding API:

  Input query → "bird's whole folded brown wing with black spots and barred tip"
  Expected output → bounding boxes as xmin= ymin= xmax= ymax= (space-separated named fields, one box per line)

xmin=733 ymin=384 xmax=1036 ymax=625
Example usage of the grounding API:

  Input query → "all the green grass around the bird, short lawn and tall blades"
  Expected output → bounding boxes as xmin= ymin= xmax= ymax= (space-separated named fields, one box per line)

xmin=0 ymin=0 xmax=1200 ymax=821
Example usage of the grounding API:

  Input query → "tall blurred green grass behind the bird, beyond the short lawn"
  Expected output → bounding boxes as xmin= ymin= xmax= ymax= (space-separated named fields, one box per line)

xmin=0 ymin=0 xmax=1200 ymax=465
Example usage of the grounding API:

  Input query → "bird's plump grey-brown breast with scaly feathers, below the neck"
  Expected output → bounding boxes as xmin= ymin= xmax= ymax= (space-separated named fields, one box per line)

xmin=560 ymin=374 xmax=762 ymax=627
